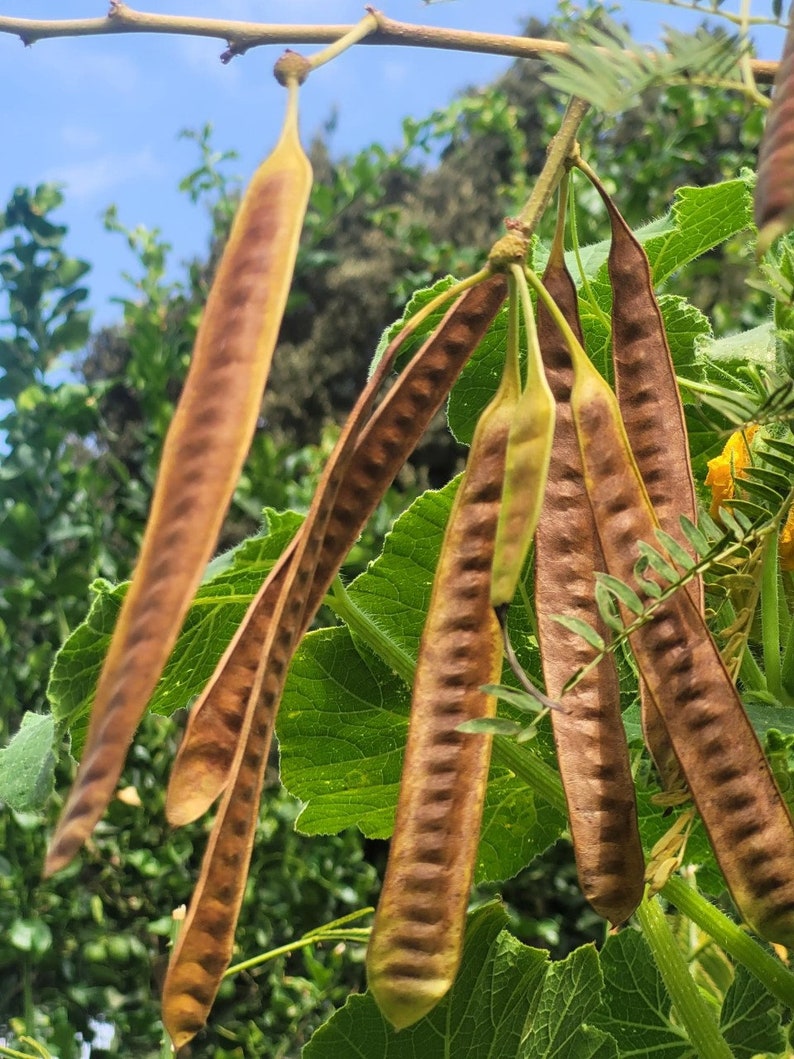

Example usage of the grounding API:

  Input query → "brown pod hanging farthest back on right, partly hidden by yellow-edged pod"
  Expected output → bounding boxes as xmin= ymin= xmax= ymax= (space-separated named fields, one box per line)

xmin=583 ymin=166 xmax=704 ymax=790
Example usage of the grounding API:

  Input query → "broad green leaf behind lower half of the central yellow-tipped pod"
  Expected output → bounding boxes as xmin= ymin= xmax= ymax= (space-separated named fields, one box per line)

xmin=277 ymin=629 xmax=563 ymax=881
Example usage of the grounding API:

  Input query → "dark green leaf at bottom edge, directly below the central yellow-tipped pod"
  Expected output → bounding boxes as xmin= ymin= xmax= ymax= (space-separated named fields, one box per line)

xmin=303 ymin=903 xmax=550 ymax=1059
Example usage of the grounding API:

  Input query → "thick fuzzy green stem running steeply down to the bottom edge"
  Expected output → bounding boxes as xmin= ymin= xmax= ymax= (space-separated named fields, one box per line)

xmin=636 ymin=897 xmax=734 ymax=1059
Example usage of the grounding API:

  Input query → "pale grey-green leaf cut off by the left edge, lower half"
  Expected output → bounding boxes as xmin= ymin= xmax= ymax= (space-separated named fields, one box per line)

xmin=0 ymin=713 xmax=55 ymax=812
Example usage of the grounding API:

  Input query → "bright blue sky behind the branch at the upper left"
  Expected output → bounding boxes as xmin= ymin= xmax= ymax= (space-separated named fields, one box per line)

xmin=0 ymin=0 xmax=781 ymax=323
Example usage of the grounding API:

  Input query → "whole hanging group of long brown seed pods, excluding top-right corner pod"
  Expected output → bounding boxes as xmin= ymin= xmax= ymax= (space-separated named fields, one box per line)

xmin=46 ymin=37 xmax=794 ymax=1047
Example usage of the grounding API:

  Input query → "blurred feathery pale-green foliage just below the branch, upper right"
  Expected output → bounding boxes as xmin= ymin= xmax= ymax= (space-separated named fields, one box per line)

xmin=544 ymin=13 xmax=746 ymax=113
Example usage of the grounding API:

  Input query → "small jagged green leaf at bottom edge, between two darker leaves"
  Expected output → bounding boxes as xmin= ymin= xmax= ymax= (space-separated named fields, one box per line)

xmin=520 ymin=945 xmax=619 ymax=1059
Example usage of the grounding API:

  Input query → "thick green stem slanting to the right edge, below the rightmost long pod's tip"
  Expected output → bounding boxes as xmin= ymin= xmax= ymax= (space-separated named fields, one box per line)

xmin=662 ymin=876 xmax=794 ymax=1008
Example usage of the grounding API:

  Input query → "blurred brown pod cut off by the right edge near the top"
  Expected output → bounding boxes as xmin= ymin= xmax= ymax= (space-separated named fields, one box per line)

xmin=755 ymin=20 xmax=794 ymax=256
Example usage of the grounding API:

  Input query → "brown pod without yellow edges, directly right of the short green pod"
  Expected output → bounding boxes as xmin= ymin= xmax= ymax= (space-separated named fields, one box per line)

xmin=535 ymin=204 xmax=645 ymax=923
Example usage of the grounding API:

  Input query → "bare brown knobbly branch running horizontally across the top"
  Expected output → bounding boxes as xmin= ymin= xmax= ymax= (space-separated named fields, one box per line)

xmin=0 ymin=0 xmax=777 ymax=84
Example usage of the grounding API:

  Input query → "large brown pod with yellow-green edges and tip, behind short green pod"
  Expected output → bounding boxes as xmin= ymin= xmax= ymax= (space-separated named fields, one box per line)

xmin=366 ymin=275 xmax=520 ymax=1029
